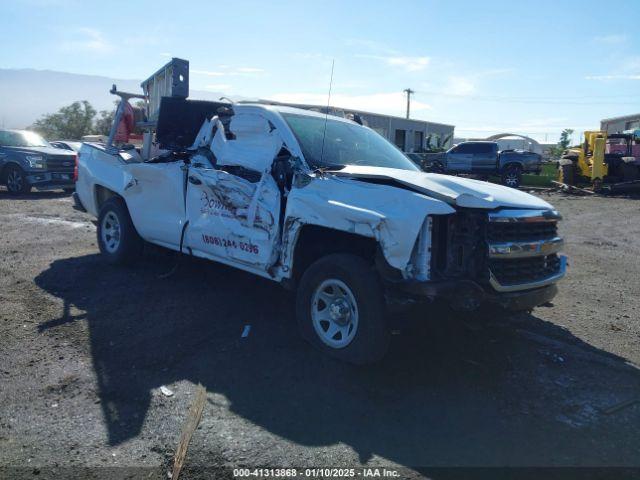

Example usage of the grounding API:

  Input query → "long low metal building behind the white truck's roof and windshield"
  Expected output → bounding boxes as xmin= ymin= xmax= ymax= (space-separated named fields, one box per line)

xmin=255 ymin=100 xmax=455 ymax=153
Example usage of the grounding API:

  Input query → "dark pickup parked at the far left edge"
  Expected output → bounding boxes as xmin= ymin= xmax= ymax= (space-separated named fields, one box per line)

xmin=0 ymin=130 xmax=77 ymax=194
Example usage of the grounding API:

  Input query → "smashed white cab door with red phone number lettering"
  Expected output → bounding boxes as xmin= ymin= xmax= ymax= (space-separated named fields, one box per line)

xmin=185 ymin=110 xmax=282 ymax=271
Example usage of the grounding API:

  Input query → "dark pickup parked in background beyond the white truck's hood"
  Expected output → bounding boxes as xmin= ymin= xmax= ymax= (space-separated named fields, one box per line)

xmin=422 ymin=142 xmax=542 ymax=188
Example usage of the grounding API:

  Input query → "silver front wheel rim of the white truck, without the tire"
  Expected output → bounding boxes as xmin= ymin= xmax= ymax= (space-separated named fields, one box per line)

xmin=311 ymin=278 xmax=358 ymax=348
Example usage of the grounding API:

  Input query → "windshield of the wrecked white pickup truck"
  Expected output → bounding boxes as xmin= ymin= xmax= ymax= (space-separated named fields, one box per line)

xmin=282 ymin=113 xmax=419 ymax=170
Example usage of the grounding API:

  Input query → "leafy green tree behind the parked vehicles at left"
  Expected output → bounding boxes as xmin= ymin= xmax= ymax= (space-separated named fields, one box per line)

xmin=29 ymin=100 xmax=96 ymax=140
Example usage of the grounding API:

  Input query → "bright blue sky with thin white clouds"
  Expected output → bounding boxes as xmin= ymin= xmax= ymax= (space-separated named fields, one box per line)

xmin=0 ymin=0 xmax=640 ymax=143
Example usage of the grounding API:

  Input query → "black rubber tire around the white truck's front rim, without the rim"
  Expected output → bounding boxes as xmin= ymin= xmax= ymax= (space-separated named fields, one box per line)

xmin=296 ymin=254 xmax=390 ymax=365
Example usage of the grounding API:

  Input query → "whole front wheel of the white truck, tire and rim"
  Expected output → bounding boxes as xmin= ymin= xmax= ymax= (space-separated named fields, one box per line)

xmin=296 ymin=254 xmax=389 ymax=365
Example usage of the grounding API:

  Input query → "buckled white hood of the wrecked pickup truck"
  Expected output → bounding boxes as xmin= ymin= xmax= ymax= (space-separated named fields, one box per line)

xmin=335 ymin=165 xmax=553 ymax=209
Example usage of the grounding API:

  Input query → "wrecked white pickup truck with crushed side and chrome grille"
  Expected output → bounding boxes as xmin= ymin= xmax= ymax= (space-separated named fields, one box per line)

xmin=76 ymin=104 xmax=566 ymax=364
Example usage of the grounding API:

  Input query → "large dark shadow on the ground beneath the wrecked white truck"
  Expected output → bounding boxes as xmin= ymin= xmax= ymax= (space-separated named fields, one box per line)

xmin=36 ymin=253 xmax=640 ymax=466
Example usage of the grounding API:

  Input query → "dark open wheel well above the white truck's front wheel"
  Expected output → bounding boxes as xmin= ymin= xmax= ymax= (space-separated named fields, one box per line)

xmin=293 ymin=225 xmax=378 ymax=283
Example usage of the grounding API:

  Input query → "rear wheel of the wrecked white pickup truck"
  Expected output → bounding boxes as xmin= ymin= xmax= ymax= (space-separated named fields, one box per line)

xmin=98 ymin=197 xmax=144 ymax=265
